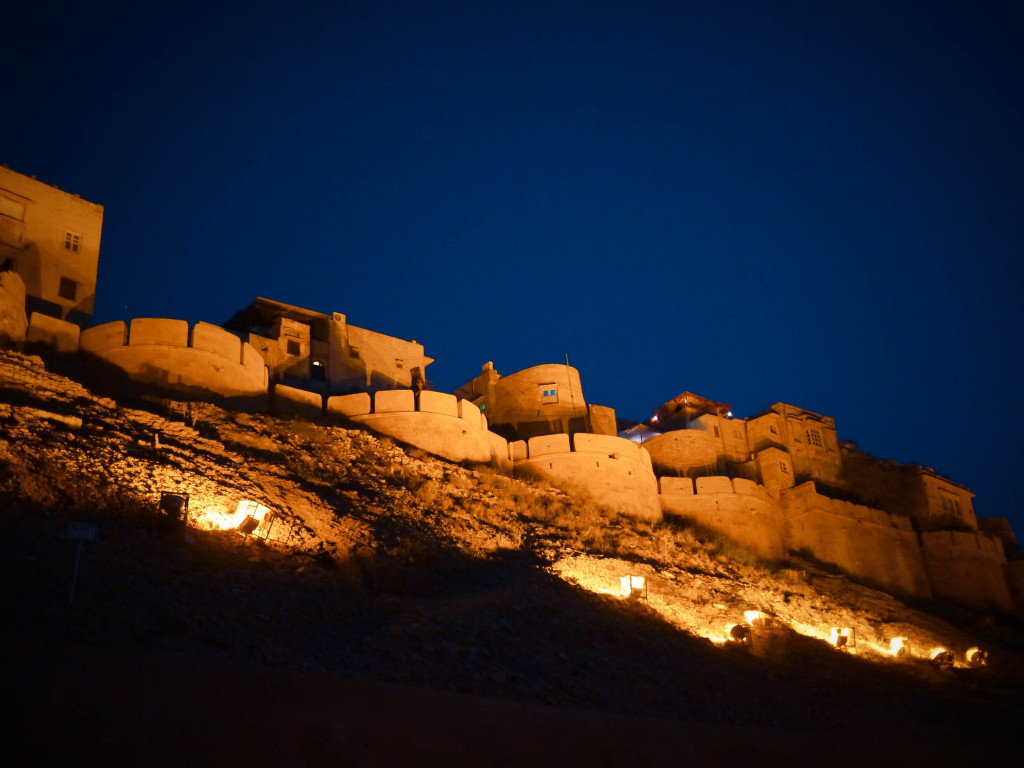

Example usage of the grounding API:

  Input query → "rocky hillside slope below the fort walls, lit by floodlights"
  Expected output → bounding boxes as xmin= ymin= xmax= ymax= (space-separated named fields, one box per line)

xmin=0 ymin=352 xmax=1024 ymax=764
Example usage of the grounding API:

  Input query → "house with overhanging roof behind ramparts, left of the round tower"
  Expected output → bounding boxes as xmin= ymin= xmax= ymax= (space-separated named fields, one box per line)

xmin=224 ymin=298 xmax=434 ymax=394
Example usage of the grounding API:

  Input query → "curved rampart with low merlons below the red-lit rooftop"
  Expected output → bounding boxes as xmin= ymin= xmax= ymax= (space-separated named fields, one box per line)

xmin=658 ymin=477 xmax=785 ymax=560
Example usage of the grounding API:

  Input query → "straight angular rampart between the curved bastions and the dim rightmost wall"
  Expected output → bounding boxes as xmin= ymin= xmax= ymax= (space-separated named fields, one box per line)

xmin=781 ymin=482 xmax=932 ymax=598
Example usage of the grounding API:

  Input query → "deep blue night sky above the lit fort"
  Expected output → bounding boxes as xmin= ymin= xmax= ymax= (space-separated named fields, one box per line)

xmin=0 ymin=0 xmax=1024 ymax=538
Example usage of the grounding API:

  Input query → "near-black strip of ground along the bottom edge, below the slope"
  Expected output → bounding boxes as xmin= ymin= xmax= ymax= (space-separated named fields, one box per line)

xmin=8 ymin=646 xmax=1016 ymax=768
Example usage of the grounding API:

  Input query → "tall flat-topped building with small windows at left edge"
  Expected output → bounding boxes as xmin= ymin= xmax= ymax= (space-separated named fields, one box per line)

xmin=0 ymin=166 xmax=103 ymax=328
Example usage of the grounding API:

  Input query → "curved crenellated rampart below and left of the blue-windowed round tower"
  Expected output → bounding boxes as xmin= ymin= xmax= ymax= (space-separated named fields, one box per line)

xmin=327 ymin=389 xmax=512 ymax=468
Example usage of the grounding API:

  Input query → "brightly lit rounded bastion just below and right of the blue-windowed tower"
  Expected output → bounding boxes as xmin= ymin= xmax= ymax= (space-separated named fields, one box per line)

xmin=510 ymin=432 xmax=662 ymax=520
